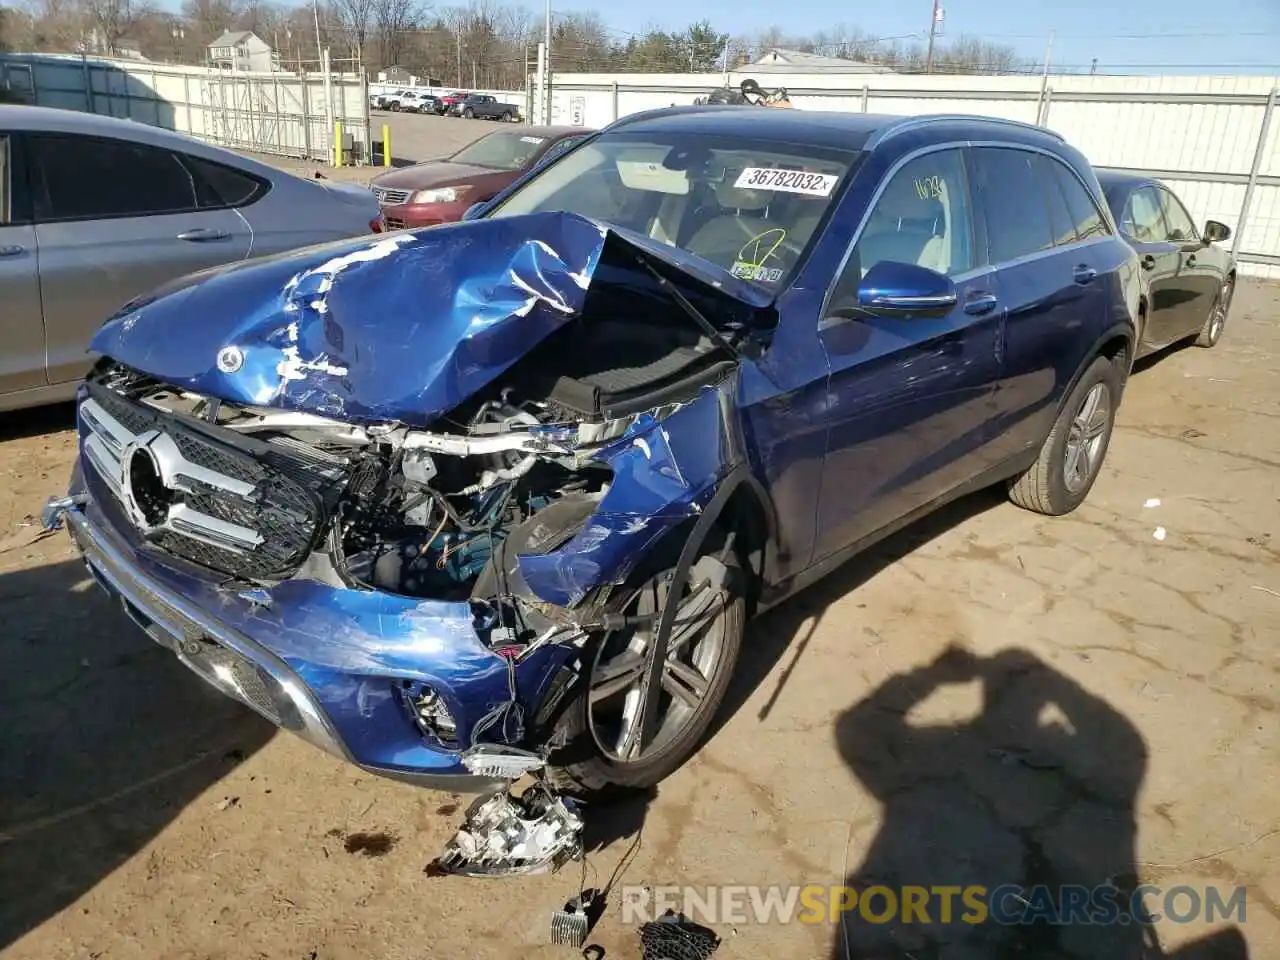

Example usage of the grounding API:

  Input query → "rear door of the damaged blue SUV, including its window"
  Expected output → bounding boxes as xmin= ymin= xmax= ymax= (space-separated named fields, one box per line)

xmin=973 ymin=145 xmax=1106 ymax=462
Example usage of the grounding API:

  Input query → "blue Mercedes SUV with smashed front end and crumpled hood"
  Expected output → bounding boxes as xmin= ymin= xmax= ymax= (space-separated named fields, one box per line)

xmin=45 ymin=108 xmax=1139 ymax=792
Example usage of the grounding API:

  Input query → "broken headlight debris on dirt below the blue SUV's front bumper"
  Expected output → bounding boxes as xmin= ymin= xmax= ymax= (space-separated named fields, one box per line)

xmin=426 ymin=781 xmax=582 ymax=877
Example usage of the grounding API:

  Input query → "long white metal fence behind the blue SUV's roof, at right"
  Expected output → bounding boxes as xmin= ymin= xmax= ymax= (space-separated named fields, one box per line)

xmin=534 ymin=73 xmax=1280 ymax=278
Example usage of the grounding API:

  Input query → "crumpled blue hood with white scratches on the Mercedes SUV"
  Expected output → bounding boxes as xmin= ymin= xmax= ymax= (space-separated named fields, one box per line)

xmin=91 ymin=212 xmax=772 ymax=425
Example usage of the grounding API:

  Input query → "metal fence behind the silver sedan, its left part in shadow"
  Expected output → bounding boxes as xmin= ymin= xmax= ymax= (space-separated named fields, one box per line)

xmin=0 ymin=54 xmax=370 ymax=160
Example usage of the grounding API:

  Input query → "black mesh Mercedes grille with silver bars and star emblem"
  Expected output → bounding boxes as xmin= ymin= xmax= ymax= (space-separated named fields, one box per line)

xmin=79 ymin=384 xmax=330 ymax=580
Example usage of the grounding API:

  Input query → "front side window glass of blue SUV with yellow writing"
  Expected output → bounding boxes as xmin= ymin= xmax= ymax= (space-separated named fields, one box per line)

xmin=847 ymin=150 xmax=974 ymax=279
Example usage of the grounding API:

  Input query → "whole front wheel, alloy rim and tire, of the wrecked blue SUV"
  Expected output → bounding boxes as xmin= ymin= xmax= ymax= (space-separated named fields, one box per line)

xmin=548 ymin=548 xmax=746 ymax=795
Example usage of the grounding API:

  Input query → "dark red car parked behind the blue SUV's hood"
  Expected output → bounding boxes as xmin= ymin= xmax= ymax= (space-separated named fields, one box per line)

xmin=369 ymin=127 xmax=593 ymax=230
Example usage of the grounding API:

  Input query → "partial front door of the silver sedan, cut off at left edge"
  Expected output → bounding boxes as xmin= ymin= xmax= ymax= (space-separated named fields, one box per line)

xmin=0 ymin=132 xmax=46 ymax=393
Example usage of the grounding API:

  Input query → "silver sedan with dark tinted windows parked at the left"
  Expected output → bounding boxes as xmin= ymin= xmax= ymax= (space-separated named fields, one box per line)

xmin=0 ymin=106 xmax=383 ymax=410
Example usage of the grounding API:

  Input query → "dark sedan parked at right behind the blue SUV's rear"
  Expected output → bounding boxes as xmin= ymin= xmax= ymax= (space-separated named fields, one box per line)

xmin=1098 ymin=170 xmax=1235 ymax=356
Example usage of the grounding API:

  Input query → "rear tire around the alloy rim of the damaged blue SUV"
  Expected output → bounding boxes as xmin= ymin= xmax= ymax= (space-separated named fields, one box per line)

xmin=1009 ymin=357 xmax=1128 ymax=517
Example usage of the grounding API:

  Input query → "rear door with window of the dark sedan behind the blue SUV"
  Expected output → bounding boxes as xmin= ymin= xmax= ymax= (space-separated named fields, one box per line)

xmin=1120 ymin=184 xmax=1196 ymax=347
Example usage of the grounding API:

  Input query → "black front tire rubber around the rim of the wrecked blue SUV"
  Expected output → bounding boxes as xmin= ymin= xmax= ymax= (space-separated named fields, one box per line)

xmin=547 ymin=544 xmax=746 ymax=796
